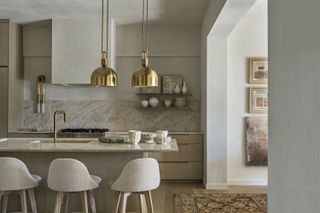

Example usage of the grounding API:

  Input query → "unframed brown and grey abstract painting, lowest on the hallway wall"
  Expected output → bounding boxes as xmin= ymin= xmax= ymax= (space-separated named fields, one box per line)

xmin=246 ymin=117 xmax=268 ymax=166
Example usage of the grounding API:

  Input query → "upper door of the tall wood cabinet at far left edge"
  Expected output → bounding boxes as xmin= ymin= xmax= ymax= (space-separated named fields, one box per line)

xmin=0 ymin=20 xmax=9 ymax=67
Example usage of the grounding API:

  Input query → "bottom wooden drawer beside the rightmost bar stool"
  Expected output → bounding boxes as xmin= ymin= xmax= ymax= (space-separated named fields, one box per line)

xmin=159 ymin=162 xmax=203 ymax=180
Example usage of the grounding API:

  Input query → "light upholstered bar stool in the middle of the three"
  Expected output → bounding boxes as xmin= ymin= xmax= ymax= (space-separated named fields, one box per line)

xmin=48 ymin=158 xmax=102 ymax=213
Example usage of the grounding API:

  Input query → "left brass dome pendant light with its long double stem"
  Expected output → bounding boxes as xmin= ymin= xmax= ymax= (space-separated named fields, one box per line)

xmin=91 ymin=0 xmax=118 ymax=87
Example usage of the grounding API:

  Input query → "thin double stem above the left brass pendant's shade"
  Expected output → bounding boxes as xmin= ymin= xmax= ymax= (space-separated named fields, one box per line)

xmin=101 ymin=0 xmax=109 ymax=55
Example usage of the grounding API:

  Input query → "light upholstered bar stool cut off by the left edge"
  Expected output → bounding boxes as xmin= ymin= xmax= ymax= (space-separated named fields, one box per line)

xmin=0 ymin=157 xmax=41 ymax=213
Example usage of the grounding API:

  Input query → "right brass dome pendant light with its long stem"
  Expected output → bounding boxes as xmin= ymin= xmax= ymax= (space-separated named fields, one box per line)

xmin=132 ymin=0 xmax=158 ymax=87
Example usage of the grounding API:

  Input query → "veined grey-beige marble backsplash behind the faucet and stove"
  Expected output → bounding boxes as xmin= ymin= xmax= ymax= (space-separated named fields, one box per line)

xmin=22 ymin=100 xmax=201 ymax=132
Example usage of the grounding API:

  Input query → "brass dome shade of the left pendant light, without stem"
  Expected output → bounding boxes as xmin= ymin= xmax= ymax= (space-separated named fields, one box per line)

xmin=91 ymin=53 xmax=118 ymax=87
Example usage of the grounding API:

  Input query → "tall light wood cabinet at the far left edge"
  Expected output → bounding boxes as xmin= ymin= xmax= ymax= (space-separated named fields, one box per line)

xmin=0 ymin=19 xmax=23 ymax=138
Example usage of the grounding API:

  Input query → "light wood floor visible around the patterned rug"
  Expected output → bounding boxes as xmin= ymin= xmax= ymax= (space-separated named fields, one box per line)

xmin=128 ymin=182 xmax=267 ymax=213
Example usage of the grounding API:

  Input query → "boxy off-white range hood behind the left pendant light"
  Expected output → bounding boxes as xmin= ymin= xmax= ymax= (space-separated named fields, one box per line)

xmin=52 ymin=19 xmax=116 ymax=84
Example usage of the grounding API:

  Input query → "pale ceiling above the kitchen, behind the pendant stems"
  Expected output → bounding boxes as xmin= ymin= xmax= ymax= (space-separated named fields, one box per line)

xmin=0 ymin=0 xmax=213 ymax=24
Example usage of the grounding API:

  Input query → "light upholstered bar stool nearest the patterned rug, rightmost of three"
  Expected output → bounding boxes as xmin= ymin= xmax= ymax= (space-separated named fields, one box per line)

xmin=111 ymin=158 xmax=160 ymax=213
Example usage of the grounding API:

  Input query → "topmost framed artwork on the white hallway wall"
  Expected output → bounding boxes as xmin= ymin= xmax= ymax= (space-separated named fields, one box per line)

xmin=248 ymin=57 xmax=268 ymax=84
